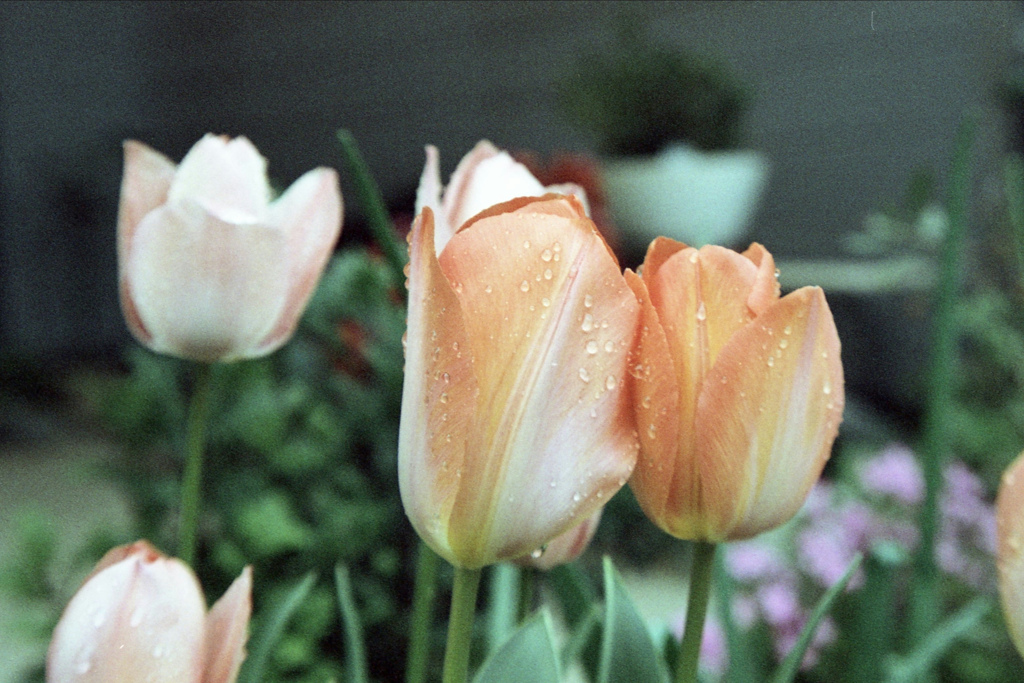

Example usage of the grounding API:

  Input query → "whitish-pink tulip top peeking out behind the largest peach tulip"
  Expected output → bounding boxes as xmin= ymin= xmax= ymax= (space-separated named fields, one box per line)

xmin=416 ymin=140 xmax=590 ymax=254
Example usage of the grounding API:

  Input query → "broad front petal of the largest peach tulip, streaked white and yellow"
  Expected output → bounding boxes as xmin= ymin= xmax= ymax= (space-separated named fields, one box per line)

xmin=442 ymin=198 xmax=638 ymax=566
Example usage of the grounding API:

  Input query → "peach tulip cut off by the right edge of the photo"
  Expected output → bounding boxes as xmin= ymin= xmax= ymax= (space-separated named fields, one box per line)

xmin=995 ymin=454 xmax=1024 ymax=656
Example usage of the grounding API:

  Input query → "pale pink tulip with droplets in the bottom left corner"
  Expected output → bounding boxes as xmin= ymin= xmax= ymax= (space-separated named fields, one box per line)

xmin=46 ymin=541 xmax=252 ymax=683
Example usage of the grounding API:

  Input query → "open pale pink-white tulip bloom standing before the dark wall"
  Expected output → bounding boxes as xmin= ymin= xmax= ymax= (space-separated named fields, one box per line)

xmin=118 ymin=135 xmax=342 ymax=362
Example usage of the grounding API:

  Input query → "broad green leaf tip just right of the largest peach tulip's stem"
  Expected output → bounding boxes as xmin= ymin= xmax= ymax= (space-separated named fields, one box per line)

xmin=473 ymin=609 xmax=561 ymax=683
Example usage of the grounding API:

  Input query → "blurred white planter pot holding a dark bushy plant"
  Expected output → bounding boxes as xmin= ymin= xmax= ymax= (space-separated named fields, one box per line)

xmin=603 ymin=144 xmax=768 ymax=247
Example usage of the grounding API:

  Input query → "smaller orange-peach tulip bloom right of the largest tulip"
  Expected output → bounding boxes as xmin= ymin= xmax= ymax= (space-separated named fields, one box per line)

xmin=627 ymin=238 xmax=844 ymax=543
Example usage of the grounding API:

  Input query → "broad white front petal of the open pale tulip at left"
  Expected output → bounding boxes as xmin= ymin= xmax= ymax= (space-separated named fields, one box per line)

xmin=125 ymin=202 xmax=289 ymax=361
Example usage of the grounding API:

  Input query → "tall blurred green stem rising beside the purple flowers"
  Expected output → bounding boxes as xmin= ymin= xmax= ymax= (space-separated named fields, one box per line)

xmin=910 ymin=116 xmax=975 ymax=663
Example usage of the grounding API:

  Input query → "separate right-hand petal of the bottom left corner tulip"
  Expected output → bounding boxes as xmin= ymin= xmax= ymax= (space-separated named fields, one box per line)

xmin=202 ymin=566 xmax=253 ymax=683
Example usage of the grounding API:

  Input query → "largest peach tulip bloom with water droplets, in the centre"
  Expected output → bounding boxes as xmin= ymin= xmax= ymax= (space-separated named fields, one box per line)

xmin=398 ymin=191 xmax=638 ymax=569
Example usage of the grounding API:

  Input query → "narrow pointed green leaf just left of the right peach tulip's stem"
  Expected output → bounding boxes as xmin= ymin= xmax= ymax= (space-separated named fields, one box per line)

xmin=597 ymin=557 xmax=669 ymax=683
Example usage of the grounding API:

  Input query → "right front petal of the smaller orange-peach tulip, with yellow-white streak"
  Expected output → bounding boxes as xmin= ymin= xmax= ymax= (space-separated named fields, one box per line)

xmin=696 ymin=287 xmax=844 ymax=541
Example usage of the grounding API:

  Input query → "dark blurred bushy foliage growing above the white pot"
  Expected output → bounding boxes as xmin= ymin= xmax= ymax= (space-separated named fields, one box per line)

xmin=558 ymin=14 xmax=750 ymax=155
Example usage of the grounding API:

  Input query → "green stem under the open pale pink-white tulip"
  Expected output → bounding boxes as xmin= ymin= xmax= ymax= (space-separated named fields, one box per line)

xmin=178 ymin=362 xmax=212 ymax=565
